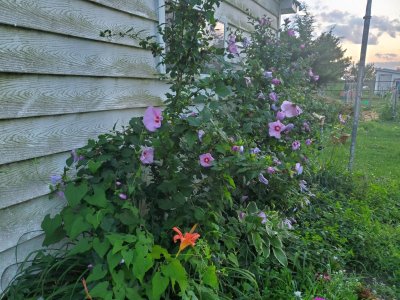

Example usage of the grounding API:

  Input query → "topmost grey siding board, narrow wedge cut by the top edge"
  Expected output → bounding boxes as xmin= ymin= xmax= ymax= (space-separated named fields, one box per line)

xmin=88 ymin=0 xmax=158 ymax=21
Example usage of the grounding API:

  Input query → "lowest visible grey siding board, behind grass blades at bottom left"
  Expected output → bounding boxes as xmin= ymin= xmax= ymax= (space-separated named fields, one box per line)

xmin=0 ymin=234 xmax=44 ymax=293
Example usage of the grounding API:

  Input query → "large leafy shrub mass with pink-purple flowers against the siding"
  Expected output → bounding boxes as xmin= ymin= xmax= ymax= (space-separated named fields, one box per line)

xmin=3 ymin=0 xmax=328 ymax=299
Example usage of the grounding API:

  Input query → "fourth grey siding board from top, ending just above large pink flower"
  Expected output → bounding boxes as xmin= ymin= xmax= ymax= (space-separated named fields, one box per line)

xmin=0 ymin=74 xmax=168 ymax=119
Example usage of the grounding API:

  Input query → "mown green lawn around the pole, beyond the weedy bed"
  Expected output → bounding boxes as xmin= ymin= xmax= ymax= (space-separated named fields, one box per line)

xmin=320 ymin=121 xmax=400 ymax=180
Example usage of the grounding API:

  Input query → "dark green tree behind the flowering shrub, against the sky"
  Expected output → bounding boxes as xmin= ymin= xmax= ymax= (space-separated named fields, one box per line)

xmin=293 ymin=7 xmax=351 ymax=85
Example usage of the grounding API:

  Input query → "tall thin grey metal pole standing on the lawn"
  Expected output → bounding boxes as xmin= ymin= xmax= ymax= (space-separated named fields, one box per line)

xmin=349 ymin=0 xmax=372 ymax=171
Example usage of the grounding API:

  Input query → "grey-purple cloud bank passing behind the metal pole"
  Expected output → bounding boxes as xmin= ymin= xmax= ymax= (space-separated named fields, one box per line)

xmin=318 ymin=10 xmax=400 ymax=45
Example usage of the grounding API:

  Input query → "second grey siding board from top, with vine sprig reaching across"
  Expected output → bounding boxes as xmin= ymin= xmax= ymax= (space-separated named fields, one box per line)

xmin=0 ymin=0 xmax=158 ymax=47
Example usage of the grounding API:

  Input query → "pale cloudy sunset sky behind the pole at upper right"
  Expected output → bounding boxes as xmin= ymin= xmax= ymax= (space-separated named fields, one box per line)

xmin=301 ymin=0 xmax=400 ymax=69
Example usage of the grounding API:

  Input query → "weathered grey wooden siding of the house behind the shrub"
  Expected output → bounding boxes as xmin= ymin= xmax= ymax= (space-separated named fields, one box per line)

xmin=0 ymin=0 xmax=279 ymax=291
